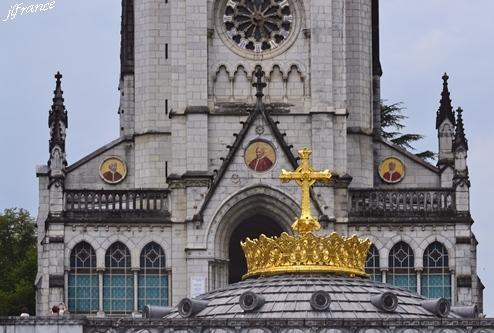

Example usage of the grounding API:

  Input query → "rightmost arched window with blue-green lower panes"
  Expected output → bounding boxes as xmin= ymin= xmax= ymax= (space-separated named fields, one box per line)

xmin=421 ymin=242 xmax=451 ymax=300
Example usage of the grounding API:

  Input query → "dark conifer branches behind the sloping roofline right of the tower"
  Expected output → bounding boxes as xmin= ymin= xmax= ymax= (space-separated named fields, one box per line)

xmin=381 ymin=102 xmax=436 ymax=160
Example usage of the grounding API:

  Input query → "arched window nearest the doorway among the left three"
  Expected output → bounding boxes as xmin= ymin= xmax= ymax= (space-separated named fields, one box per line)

xmin=138 ymin=242 xmax=168 ymax=310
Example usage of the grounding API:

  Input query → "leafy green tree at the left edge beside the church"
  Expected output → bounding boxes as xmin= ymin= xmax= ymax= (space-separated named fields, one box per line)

xmin=0 ymin=208 xmax=37 ymax=316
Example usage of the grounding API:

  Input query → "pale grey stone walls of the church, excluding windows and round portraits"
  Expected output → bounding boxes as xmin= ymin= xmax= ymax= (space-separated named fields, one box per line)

xmin=36 ymin=0 xmax=482 ymax=315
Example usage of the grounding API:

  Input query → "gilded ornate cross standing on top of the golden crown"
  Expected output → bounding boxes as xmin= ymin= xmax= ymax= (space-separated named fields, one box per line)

xmin=280 ymin=148 xmax=331 ymax=234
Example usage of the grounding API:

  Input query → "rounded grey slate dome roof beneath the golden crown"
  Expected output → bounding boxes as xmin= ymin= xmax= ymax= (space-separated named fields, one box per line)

xmin=165 ymin=274 xmax=459 ymax=319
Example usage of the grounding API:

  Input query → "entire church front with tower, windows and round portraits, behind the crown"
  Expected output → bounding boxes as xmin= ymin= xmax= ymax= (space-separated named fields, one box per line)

xmin=35 ymin=0 xmax=483 ymax=316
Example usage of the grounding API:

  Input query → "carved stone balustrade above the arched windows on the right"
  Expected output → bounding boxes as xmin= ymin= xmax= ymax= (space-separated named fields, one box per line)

xmin=349 ymin=188 xmax=456 ymax=217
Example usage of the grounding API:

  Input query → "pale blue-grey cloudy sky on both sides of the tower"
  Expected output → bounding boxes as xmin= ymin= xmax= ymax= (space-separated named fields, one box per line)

xmin=0 ymin=0 xmax=494 ymax=317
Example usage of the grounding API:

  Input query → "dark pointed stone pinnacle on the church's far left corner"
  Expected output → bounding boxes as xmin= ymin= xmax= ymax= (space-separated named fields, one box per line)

xmin=48 ymin=72 xmax=68 ymax=171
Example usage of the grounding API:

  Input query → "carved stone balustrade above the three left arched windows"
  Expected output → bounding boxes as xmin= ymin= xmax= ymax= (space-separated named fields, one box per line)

xmin=64 ymin=190 xmax=168 ymax=212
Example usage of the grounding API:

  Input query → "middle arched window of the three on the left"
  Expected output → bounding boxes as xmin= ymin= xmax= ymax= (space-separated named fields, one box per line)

xmin=103 ymin=242 xmax=134 ymax=314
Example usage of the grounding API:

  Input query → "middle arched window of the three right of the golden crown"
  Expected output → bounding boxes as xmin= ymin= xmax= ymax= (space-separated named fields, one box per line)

xmin=387 ymin=242 xmax=417 ymax=292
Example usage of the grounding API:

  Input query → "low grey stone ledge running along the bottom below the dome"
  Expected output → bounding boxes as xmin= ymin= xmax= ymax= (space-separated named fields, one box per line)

xmin=0 ymin=316 xmax=494 ymax=333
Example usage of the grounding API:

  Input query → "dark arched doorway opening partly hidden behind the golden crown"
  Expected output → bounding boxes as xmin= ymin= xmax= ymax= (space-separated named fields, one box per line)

xmin=228 ymin=215 xmax=284 ymax=283
